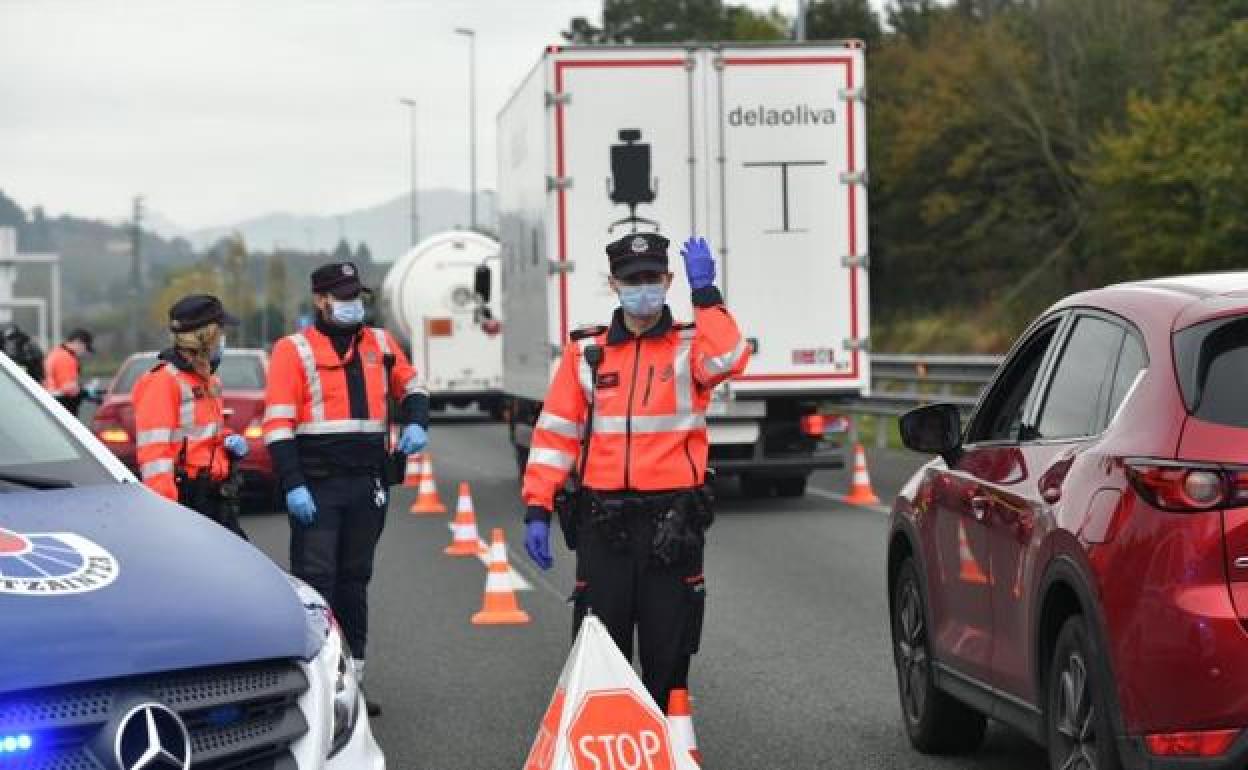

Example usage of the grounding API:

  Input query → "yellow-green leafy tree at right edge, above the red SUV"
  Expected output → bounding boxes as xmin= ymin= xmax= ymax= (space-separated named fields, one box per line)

xmin=1088 ymin=21 xmax=1248 ymax=277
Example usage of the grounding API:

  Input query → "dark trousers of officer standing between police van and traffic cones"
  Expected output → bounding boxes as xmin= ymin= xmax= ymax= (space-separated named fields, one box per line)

xmin=291 ymin=475 xmax=389 ymax=658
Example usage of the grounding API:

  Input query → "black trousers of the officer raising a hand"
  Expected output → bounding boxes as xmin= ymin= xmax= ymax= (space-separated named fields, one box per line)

xmin=573 ymin=501 xmax=706 ymax=711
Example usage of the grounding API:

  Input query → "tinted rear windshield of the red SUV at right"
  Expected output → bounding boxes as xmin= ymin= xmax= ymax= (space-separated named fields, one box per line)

xmin=1174 ymin=316 xmax=1248 ymax=428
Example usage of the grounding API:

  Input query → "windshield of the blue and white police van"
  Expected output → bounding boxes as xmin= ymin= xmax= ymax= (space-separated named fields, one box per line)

xmin=0 ymin=366 xmax=117 ymax=486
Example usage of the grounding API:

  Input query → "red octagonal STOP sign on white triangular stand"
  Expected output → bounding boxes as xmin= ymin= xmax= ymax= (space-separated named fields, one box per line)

xmin=568 ymin=690 xmax=675 ymax=770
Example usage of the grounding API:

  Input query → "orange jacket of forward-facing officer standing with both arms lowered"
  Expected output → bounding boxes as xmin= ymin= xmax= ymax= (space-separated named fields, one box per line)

xmin=263 ymin=327 xmax=427 ymax=444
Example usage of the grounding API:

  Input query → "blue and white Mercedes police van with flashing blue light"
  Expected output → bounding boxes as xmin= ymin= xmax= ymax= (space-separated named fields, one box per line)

xmin=0 ymin=354 xmax=386 ymax=770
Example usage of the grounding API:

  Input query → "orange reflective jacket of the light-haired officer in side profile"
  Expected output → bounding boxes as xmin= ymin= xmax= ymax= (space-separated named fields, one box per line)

xmin=134 ymin=361 xmax=230 ymax=502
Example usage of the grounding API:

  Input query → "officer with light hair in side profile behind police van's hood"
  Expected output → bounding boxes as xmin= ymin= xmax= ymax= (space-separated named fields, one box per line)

xmin=134 ymin=295 xmax=247 ymax=539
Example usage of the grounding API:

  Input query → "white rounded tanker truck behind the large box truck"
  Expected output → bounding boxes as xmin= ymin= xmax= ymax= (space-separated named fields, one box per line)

xmin=382 ymin=231 xmax=503 ymax=419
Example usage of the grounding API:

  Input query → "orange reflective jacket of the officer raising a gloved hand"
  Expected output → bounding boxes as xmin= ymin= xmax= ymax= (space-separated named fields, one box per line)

xmin=523 ymin=300 xmax=750 ymax=510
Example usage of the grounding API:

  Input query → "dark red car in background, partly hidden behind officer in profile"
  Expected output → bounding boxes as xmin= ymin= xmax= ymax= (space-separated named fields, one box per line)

xmin=92 ymin=348 xmax=276 ymax=502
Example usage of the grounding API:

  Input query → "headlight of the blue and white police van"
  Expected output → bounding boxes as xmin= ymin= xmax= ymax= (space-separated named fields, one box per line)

xmin=291 ymin=577 xmax=363 ymax=756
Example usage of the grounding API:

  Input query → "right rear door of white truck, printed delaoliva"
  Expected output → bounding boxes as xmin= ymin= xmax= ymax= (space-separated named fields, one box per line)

xmin=705 ymin=45 xmax=869 ymax=393
